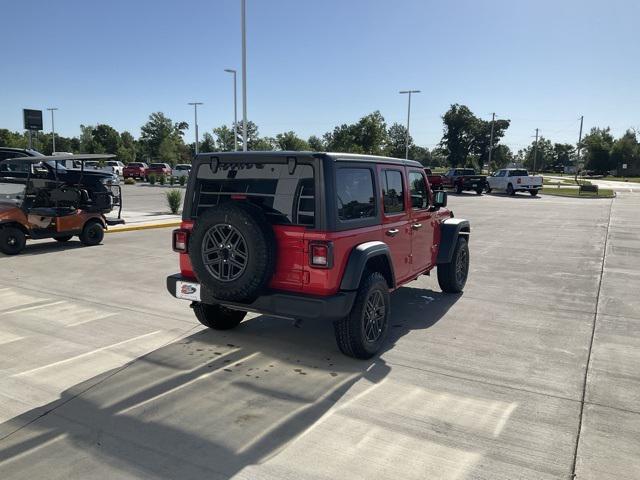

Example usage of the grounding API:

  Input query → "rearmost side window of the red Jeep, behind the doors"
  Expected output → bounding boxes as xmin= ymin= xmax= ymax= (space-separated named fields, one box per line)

xmin=336 ymin=168 xmax=376 ymax=220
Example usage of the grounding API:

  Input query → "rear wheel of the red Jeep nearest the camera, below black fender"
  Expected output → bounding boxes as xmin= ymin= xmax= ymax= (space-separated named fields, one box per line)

xmin=333 ymin=272 xmax=391 ymax=360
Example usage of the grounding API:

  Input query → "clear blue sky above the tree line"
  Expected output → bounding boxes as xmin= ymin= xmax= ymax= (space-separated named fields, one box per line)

xmin=0 ymin=0 xmax=640 ymax=151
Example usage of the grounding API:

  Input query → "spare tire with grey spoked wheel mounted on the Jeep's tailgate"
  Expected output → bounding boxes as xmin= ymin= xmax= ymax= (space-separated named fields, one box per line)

xmin=189 ymin=201 xmax=276 ymax=301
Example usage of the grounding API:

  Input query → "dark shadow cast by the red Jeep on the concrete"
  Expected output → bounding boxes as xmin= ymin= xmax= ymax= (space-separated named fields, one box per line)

xmin=0 ymin=288 xmax=459 ymax=479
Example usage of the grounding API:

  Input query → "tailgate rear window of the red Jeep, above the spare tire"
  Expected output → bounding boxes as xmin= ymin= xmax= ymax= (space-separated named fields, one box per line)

xmin=192 ymin=163 xmax=315 ymax=227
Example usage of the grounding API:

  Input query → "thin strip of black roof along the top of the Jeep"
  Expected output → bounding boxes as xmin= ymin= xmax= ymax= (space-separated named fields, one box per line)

xmin=194 ymin=151 xmax=423 ymax=168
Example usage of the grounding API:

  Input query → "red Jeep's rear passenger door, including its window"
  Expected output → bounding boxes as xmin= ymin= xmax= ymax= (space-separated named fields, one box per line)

xmin=378 ymin=165 xmax=411 ymax=282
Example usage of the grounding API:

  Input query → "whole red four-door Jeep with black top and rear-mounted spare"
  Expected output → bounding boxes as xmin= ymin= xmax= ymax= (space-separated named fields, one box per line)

xmin=167 ymin=152 xmax=470 ymax=358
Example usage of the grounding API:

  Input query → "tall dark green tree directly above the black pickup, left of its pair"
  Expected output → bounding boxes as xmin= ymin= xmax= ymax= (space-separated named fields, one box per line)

xmin=441 ymin=103 xmax=478 ymax=167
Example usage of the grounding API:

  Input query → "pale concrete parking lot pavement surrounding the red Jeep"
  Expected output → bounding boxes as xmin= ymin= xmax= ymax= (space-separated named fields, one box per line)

xmin=0 ymin=193 xmax=640 ymax=480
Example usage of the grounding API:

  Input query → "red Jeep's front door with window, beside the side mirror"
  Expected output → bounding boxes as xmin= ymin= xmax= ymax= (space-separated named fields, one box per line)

xmin=407 ymin=168 xmax=435 ymax=274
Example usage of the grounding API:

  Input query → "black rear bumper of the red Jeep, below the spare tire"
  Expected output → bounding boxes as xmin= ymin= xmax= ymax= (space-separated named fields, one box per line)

xmin=167 ymin=273 xmax=356 ymax=321
